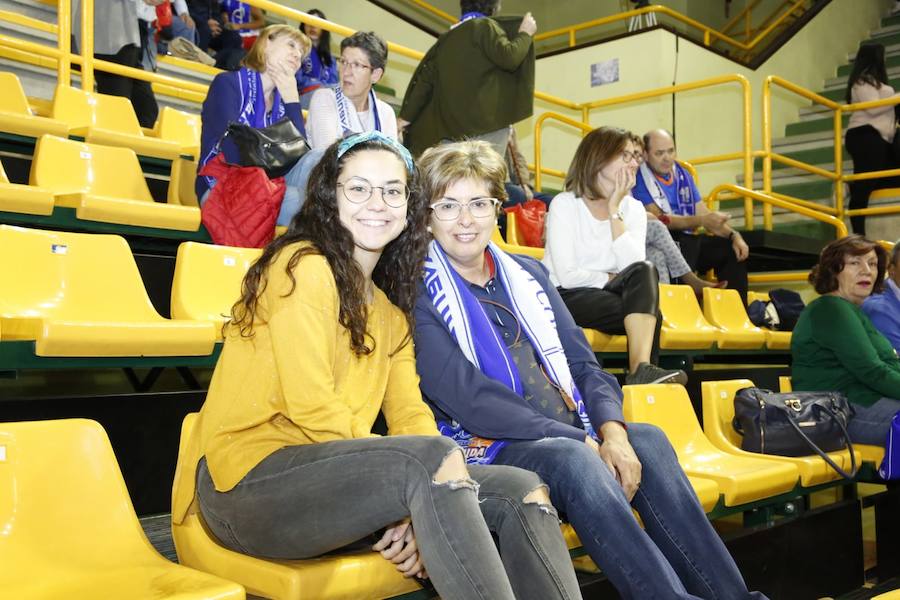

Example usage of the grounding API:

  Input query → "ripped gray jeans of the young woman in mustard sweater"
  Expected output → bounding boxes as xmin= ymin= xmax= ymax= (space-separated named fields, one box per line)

xmin=197 ymin=436 xmax=581 ymax=600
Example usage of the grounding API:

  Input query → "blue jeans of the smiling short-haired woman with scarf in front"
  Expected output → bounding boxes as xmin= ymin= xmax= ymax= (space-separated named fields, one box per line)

xmin=489 ymin=423 xmax=765 ymax=600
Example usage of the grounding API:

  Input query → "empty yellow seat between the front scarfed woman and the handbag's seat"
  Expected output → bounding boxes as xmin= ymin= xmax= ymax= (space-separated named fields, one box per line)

xmin=624 ymin=384 xmax=800 ymax=506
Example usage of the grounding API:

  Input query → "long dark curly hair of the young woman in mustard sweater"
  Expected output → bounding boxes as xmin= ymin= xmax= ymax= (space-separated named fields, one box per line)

xmin=230 ymin=140 xmax=428 ymax=356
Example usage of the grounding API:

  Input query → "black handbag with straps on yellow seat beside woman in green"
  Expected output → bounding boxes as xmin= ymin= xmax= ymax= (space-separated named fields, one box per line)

xmin=732 ymin=387 xmax=857 ymax=479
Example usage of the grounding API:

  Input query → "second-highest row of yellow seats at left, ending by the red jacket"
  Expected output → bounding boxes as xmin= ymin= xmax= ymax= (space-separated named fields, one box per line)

xmin=0 ymin=134 xmax=200 ymax=232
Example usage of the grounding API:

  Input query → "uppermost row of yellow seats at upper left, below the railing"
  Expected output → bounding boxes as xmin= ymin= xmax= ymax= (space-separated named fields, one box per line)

xmin=0 ymin=72 xmax=201 ymax=160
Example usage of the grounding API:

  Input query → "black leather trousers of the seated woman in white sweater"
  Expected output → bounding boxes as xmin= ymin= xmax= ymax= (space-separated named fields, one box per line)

xmin=558 ymin=261 xmax=662 ymax=364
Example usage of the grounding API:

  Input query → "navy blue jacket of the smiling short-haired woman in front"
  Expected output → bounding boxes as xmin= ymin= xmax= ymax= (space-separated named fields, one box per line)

xmin=415 ymin=254 xmax=625 ymax=441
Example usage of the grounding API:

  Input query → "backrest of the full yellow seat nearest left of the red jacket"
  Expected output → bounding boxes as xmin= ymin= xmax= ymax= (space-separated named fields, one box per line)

xmin=30 ymin=135 xmax=153 ymax=202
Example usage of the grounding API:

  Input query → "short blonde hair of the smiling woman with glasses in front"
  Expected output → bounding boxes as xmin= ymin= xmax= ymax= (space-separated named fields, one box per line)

xmin=416 ymin=141 xmax=507 ymax=203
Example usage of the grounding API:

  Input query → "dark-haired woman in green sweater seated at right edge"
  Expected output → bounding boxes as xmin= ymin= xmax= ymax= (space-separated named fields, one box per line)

xmin=791 ymin=234 xmax=900 ymax=446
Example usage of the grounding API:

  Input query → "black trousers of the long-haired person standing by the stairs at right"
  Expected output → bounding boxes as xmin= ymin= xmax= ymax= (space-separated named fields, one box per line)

xmin=845 ymin=125 xmax=900 ymax=235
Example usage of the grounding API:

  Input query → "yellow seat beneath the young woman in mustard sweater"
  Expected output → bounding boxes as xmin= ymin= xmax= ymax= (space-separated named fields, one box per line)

xmin=172 ymin=413 xmax=421 ymax=600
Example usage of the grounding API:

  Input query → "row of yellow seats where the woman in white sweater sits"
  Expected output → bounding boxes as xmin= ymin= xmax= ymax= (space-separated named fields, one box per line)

xmin=493 ymin=225 xmax=791 ymax=352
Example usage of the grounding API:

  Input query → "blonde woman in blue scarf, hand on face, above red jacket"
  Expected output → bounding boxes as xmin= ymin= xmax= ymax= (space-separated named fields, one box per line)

xmin=195 ymin=25 xmax=322 ymax=225
